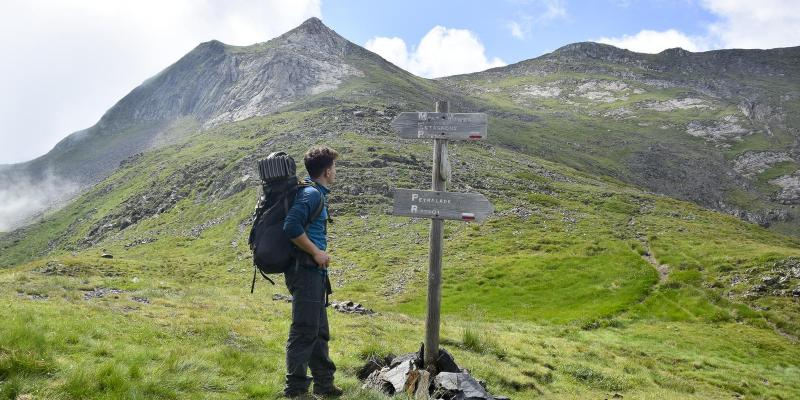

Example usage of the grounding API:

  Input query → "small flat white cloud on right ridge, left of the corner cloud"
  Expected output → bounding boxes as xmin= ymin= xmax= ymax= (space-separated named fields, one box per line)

xmin=595 ymin=29 xmax=706 ymax=53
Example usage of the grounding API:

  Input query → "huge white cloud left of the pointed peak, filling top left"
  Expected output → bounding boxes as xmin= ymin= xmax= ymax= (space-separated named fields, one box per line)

xmin=0 ymin=0 xmax=321 ymax=163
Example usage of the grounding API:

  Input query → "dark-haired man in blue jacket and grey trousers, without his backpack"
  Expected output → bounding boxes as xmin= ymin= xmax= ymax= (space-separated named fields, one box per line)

xmin=283 ymin=146 xmax=342 ymax=397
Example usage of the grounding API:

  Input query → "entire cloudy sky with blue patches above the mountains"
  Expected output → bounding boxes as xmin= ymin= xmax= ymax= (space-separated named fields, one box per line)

xmin=0 ymin=0 xmax=800 ymax=164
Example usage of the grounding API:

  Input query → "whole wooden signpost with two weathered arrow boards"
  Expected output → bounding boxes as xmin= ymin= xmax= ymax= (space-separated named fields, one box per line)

xmin=391 ymin=101 xmax=493 ymax=370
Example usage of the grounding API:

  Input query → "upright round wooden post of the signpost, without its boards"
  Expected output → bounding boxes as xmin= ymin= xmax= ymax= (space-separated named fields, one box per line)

xmin=424 ymin=101 xmax=450 ymax=368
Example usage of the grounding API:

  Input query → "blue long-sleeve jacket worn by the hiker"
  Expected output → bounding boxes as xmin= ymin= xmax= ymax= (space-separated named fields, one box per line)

xmin=283 ymin=177 xmax=330 ymax=251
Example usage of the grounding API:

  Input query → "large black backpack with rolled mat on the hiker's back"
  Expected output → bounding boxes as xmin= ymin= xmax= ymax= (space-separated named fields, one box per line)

xmin=248 ymin=152 xmax=325 ymax=293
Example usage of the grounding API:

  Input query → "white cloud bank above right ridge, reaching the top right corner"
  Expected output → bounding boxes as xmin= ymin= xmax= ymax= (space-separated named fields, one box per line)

xmin=595 ymin=0 xmax=800 ymax=53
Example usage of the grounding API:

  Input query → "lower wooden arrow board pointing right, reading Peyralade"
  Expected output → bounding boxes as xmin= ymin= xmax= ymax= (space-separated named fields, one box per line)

xmin=392 ymin=189 xmax=494 ymax=221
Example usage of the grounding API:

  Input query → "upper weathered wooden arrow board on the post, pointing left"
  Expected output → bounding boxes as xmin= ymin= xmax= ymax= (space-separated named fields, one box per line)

xmin=391 ymin=112 xmax=487 ymax=140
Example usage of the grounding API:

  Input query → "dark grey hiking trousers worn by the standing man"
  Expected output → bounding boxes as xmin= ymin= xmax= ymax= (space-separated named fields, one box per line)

xmin=284 ymin=262 xmax=336 ymax=395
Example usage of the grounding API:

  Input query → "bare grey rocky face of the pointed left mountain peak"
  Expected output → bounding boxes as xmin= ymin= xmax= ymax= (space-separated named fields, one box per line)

xmin=104 ymin=18 xmax=363 ymax=124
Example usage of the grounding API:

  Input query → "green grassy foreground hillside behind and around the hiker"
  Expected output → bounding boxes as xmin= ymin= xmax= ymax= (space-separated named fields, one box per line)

xmin=0 ymin=97 xmax=800 ymax=399
